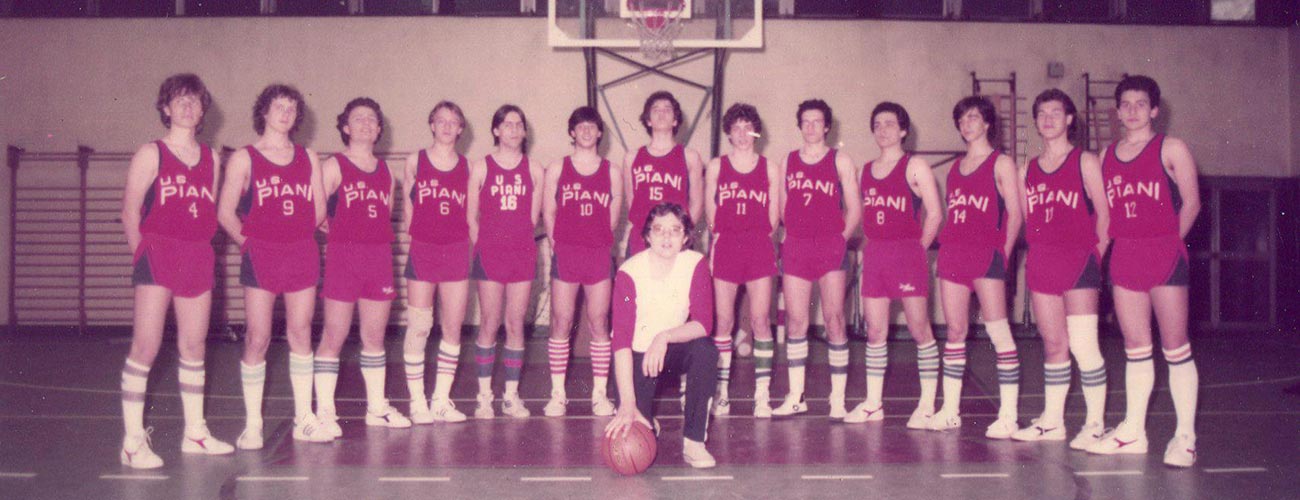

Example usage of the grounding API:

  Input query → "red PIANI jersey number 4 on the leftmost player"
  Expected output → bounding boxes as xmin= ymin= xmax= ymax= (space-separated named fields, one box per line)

xmin=140 ymin=140 xmax=217 ymax=242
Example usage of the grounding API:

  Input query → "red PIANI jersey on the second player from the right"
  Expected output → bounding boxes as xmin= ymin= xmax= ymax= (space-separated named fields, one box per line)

xmin=1024 ymin=148 xmax=1097 ymax=248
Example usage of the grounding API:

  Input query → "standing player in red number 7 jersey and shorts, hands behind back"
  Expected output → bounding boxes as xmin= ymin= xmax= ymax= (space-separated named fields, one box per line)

xmin=772 ymin=99 xmax=862 ymax=418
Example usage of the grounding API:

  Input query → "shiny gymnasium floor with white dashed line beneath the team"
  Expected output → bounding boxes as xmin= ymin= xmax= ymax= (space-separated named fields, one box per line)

xmin=0 ymin=332 xmax=1300 ymax=500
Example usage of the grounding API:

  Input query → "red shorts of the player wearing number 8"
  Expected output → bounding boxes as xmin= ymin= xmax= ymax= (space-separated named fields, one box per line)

xmin=862 ymin=239 xmax=930 ymax=299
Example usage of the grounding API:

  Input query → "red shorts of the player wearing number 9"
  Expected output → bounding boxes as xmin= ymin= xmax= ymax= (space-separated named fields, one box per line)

xmin=239 ymin=238 xmax=321 ymax=295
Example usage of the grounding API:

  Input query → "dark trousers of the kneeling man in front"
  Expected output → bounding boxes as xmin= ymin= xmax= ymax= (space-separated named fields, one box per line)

xmin=632 ymin=336 xmax=718 ymax=443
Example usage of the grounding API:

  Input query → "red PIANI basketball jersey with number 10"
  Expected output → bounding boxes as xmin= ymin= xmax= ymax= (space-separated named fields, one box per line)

xmin=554 ymin=156 xmax=614 ymax=247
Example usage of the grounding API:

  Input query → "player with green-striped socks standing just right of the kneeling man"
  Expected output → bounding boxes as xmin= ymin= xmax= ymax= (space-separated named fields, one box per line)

xmin=705 ymin=103 xmax=781 ymax=418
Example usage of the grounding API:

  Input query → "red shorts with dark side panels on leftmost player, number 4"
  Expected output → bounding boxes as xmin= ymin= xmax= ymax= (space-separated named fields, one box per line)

xmin=131 ymin=234 xmax=216 ymax=297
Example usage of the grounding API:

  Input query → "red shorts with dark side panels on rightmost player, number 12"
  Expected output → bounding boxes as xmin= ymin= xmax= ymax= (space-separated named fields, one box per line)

xmin=1110 ymin=236 xmax=1190 ymax=292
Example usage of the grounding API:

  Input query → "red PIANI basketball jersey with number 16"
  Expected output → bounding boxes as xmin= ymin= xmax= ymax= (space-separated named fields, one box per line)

xmin=478 ymin=155 xmax=533 ymax=248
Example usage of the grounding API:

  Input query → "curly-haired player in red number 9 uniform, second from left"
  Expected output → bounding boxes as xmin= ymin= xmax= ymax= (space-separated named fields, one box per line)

xmin=217 ymin=84 xmax=333 ymax=449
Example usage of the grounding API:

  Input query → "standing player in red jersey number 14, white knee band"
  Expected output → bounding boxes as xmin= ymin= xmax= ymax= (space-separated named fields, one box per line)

xmin=930 ymin=96 xmax=1023 ymax=439
